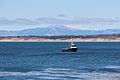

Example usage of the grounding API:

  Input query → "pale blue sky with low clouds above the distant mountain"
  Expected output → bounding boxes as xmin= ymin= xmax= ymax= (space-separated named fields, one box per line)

xmin=0 ymin=0 xmax=120 ymax=30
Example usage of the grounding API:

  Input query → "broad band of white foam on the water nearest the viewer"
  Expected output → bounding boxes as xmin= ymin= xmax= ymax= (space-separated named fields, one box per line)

xmin=0 ymin=67 xmax=120 ymax=80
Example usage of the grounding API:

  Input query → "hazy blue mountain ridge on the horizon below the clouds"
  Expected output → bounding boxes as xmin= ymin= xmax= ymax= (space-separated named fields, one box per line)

xmin=0 ymin=25 xmax=120 ymax=36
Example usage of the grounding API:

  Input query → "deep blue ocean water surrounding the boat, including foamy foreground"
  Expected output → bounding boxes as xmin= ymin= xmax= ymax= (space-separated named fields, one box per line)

xmin=0 ymin=42 xmax=120 ymax=80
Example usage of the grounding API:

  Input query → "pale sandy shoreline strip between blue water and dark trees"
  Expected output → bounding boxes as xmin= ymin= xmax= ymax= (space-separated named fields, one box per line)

xmin=0 ymin=38 xmax=120 ymax=42
